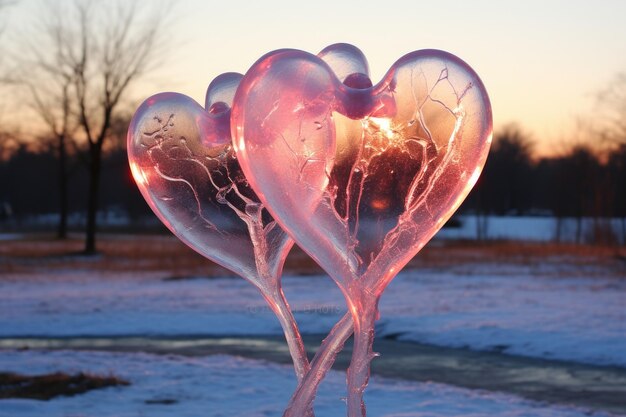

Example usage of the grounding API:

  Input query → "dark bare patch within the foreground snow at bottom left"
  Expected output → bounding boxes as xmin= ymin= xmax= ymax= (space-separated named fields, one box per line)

xmin=0 ymin=372 xmax=130 ymax=401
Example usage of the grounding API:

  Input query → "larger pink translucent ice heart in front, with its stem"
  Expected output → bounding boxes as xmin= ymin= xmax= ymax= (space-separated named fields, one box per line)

xmin=231 ymin=44 xmax=492 ymax=416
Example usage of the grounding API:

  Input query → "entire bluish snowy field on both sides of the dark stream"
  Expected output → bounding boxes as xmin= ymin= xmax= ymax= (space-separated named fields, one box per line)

xmin=0 ymin=232 xmax=626 ymax=417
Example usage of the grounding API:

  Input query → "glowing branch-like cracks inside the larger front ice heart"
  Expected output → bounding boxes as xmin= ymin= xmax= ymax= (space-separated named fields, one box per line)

xmin=325 ymin=65 xmax=473 ymax=277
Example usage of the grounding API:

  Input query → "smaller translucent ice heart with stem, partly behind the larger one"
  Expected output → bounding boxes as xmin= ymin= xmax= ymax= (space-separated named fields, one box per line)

xmin=128 ymin=73 xmax=308 ymax=379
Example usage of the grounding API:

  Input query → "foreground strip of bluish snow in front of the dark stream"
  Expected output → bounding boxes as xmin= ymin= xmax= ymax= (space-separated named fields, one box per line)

xmin=0 ymin=351 xmax=610 ymax=417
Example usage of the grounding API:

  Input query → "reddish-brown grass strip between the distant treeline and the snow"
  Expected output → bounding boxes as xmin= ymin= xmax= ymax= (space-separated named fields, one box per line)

xmin=0 ymin=234 xmax=626 ymax=279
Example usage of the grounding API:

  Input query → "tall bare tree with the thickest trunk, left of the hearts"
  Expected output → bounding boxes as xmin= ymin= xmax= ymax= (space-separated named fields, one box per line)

xmin=26 ymin=0 xmax=168 ymax=254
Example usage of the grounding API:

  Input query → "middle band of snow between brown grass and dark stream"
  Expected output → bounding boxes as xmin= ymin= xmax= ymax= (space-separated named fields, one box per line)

xmin=0 ymin=264 xmax=626 ymax=366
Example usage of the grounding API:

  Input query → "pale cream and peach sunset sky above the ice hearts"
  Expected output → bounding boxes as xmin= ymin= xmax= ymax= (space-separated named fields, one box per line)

xmin=1 ymin=0 xmax=626 ymax=154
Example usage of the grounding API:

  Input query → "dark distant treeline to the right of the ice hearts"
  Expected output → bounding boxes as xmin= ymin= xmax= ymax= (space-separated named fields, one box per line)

xmin=461 ymin=127 xmax=626 ymax=244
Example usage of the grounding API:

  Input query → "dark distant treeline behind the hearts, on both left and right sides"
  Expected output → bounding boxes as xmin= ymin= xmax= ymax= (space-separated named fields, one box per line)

xmin=0 ymin=128 xmax=626 ymax=242
